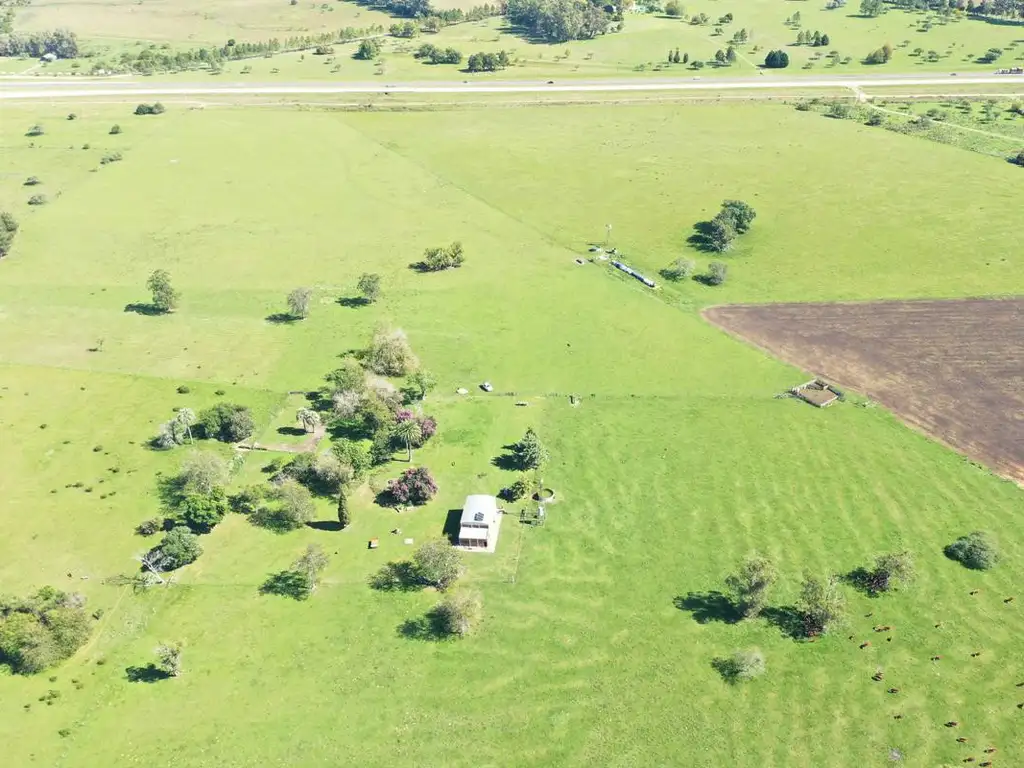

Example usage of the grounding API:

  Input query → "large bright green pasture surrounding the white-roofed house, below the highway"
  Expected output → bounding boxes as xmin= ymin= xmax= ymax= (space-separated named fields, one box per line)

xmin=0 ymin=102 xmax=1024 ymax=768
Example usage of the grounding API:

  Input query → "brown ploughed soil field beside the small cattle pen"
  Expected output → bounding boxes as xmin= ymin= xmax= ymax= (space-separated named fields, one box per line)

xmin=705 ymin=298 xmax=1024 ymax=484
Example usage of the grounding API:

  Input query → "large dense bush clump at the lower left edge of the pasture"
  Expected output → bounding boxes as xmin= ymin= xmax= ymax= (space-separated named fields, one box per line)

xmin=0 ymin=587 xmax=91 ymax=675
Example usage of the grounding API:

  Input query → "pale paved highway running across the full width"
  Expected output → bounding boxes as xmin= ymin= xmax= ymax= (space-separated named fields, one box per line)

xmin=0 ymin=73 xmax=1024 ymax=100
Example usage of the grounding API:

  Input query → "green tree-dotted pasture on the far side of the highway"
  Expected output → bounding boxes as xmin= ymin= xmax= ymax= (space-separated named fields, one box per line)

xmin=6 ymin=0 xmax=1024 ymax=80
